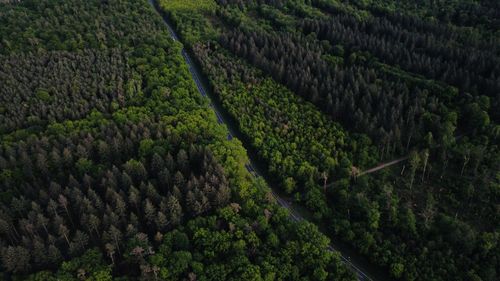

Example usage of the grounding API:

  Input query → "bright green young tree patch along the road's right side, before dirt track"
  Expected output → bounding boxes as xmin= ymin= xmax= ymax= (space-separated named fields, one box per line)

xmin=195 ymin=43 xmax=366 ymax=198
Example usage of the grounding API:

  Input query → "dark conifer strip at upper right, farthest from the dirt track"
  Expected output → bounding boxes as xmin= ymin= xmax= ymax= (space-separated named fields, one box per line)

xmin=301 ymin=14 xmax=500 ymax=97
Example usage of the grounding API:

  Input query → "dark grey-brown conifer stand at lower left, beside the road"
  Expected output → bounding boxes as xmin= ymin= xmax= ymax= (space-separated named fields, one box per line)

xmin=0 ymin=115 xmax=231 ymax=273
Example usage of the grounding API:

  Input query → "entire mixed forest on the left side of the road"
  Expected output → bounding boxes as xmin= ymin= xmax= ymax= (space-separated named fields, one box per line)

xmin=0 ymin=0 xmax=356 ymax=281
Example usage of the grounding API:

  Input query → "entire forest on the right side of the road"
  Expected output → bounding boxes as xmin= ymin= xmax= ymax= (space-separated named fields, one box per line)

xmin=159 ymin=0 xmax=500 ymax=281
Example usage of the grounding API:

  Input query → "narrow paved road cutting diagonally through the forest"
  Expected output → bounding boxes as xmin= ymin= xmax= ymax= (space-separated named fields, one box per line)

xmin=148 ymin=0 xmax=374 ymax=281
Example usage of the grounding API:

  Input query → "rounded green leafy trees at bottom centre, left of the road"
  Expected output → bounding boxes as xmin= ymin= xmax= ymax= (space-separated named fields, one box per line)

xmin=146 ymin=206 xmax=353 ymax=280
